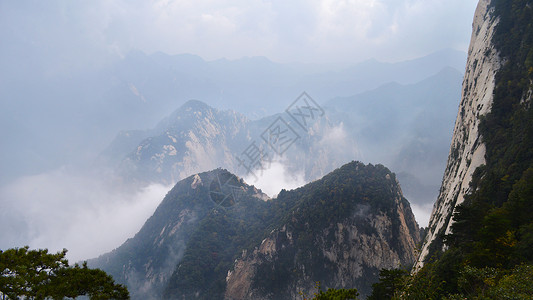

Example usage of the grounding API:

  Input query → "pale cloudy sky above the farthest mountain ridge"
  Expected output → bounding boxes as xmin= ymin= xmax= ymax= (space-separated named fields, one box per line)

xmin=0 ymin=0 xmax=477 ymax=65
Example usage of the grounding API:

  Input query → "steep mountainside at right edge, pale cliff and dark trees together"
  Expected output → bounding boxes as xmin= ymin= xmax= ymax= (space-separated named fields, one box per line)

xmin=399 ymin=0 xmax=533 ymax=299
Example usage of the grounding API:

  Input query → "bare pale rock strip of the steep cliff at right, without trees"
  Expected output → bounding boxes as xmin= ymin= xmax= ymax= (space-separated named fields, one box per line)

xmin=415 ymin=0 xmax=502 ymax=269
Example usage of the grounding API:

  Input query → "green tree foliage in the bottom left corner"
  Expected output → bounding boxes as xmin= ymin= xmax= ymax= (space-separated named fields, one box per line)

xmin=0 ymin=247 xmax=129 ymax=299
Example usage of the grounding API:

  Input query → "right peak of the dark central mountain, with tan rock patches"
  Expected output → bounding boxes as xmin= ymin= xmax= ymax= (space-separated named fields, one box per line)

xmin=225 ymin=163 xmax=420 ymax=299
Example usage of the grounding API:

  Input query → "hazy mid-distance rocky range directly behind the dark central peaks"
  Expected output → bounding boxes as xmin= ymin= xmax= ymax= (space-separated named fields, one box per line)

xmin=100 ymin=68 xmax=462 ymax=207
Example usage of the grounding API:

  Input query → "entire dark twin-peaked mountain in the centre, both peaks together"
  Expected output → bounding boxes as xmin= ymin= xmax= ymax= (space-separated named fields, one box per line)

xmin=89 ymin=162 xmax=421 ymax=299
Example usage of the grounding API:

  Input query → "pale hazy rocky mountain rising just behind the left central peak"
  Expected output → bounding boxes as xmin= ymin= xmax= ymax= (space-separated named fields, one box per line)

xmin=119 ymin=100 xmax=249 ymax=184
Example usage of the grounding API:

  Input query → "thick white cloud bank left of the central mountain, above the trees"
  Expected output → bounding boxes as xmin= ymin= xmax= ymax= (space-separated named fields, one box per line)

xmin=0 ymin=168 xmax=170 ymax=262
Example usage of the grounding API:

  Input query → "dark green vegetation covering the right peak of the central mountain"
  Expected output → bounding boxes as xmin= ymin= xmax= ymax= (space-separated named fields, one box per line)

xmin=163 ymin=162 xmax=419 ymax=299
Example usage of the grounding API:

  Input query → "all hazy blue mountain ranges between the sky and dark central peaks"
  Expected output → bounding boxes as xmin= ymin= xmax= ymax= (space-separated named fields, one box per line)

xmin=0 ymin=50 xmax=465 ymax=262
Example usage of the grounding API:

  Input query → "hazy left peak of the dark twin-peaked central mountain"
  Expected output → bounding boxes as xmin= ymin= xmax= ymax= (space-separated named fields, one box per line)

xmin=89 ymin=169 xmax=268 ymax=299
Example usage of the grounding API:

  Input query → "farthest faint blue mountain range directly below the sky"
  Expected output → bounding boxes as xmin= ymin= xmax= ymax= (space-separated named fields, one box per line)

xmin=0 ymin=49 xmax=466 ymax=185
